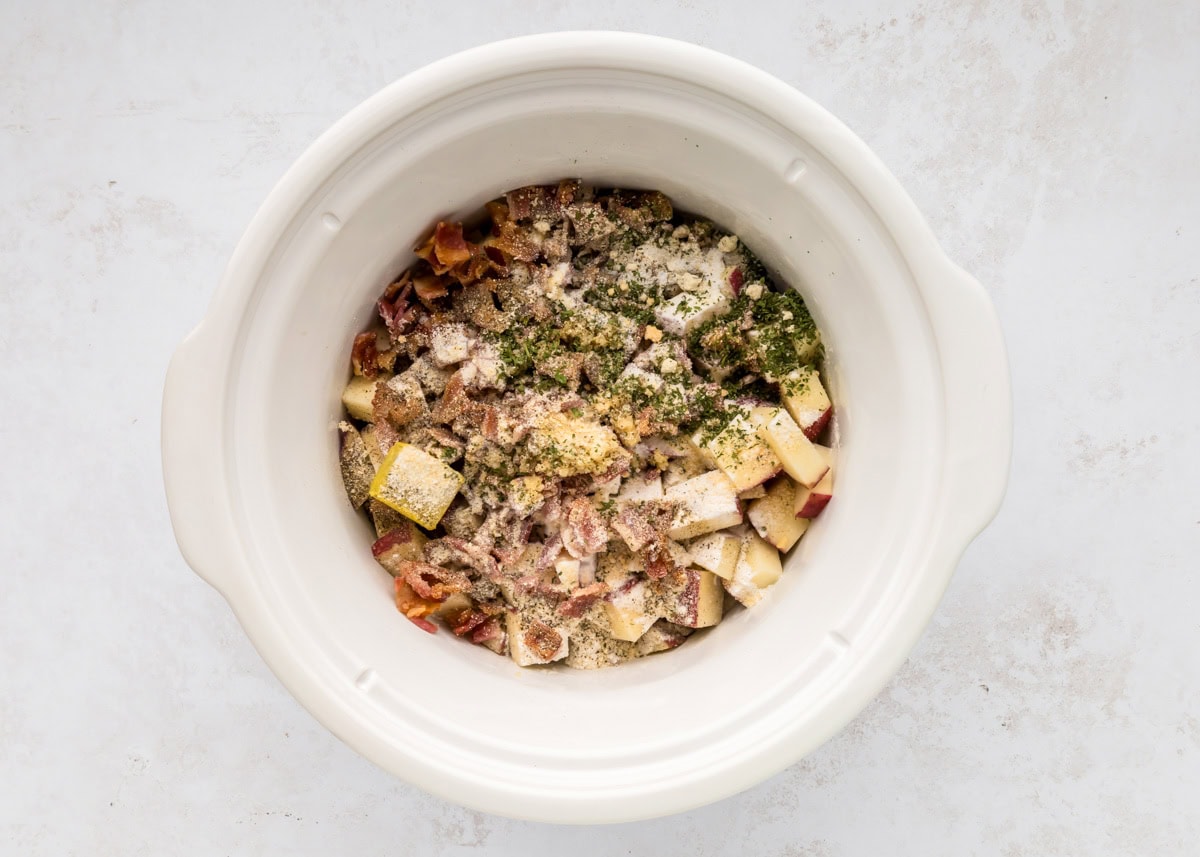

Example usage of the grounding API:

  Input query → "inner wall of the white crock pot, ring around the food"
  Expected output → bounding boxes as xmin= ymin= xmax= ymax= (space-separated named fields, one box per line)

xmin=228 ymin=73 xmax=941 ymax=767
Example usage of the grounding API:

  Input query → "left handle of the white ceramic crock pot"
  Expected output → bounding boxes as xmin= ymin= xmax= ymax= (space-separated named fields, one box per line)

xmin=162 ymin=328 xmax=241 ymax=600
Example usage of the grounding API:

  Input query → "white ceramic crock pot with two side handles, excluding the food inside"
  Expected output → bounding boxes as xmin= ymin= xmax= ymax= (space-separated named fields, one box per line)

xmin=162 ymin=32 xmax=1012 ymax=822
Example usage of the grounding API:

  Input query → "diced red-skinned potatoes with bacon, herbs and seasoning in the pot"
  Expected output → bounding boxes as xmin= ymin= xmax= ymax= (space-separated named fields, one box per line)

xmin=340 ymin=181 xmax=833 ymax=669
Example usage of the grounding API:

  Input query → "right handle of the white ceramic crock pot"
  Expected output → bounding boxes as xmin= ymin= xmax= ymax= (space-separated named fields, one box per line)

xmin=928 ymin=262 xmax=1013 ymax=547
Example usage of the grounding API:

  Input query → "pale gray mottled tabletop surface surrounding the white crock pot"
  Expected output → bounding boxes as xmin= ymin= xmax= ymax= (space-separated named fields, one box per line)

xmin=0 ymin=0 xmax=1200 ymax=857
